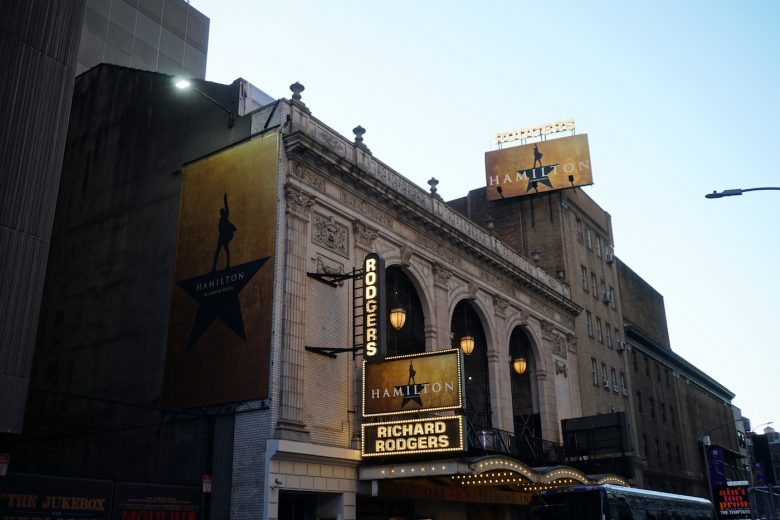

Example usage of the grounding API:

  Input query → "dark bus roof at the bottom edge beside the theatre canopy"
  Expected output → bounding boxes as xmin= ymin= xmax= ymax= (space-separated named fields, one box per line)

xmin=531 ymin=484 xmax=716 ymax=520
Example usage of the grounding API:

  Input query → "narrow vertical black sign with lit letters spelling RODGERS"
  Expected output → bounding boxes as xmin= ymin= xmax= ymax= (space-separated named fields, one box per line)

xmin=363 ymin=253 xmax=387 ymax=363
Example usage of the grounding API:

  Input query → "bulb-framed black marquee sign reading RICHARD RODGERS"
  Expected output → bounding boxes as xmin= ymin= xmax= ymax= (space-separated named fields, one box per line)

xmin=362 ymin=416 xmax=464 ymax=457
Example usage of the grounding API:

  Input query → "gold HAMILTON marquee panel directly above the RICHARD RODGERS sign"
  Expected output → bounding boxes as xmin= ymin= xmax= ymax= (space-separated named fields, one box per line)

xmin=363 ymin=349 xmax=463 ymax=417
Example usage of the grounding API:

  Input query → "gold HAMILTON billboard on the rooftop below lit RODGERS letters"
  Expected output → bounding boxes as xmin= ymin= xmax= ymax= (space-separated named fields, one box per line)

xmin=485 ymin=134 xmax=593 ymax=200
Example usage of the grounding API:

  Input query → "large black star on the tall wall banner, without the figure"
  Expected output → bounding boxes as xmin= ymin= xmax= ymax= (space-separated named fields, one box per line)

xmin=178 ymin=256 xmax=270 ymax=350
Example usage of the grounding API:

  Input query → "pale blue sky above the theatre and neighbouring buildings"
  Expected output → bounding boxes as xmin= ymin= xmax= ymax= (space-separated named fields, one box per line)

xmin=191 ymin=0 xmax=780 ymax=433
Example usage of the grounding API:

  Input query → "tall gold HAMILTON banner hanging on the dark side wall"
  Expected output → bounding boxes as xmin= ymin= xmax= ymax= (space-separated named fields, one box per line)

xmin=163 ymin=133 xmax=279 ymax=407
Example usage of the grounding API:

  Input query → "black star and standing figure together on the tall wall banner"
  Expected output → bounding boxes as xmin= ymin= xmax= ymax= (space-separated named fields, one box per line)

xmin=177 ymin=193 xmax=270 ymax=350
